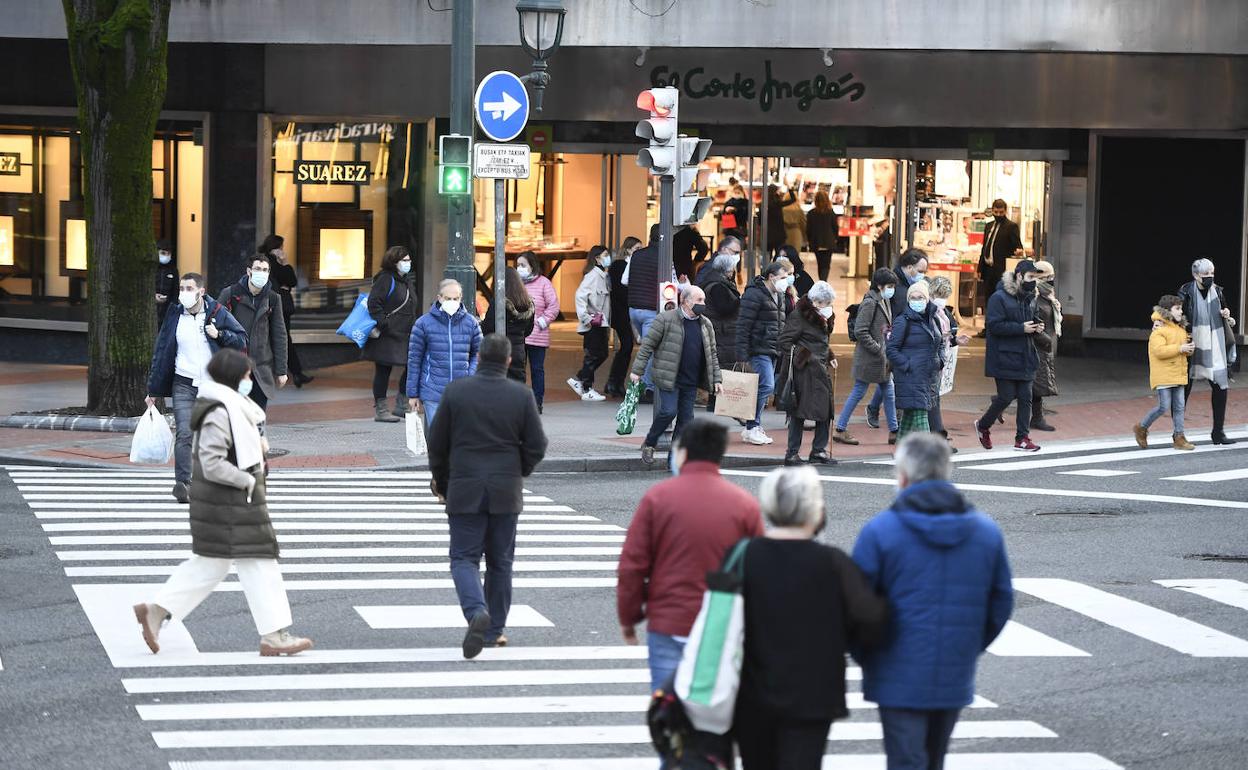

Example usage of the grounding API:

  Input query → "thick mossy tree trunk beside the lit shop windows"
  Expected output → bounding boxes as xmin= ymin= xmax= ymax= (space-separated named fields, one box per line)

xmin=62 ymin=0 xmax=170 ymax=416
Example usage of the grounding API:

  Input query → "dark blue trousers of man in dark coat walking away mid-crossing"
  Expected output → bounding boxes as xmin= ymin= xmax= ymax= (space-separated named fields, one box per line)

xmin=448 ymin=513 xmax=520 ymax=640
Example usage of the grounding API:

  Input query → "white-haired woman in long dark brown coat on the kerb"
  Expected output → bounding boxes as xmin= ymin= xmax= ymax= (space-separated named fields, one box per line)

xmin=779 ymin=281 xmax=839 ymax=465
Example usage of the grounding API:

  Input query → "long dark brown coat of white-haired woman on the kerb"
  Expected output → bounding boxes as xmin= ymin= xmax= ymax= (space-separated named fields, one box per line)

xmin=776 ymin=297 xmax=836 ymax=422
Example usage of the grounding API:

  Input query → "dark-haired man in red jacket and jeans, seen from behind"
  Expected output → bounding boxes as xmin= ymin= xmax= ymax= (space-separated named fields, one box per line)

xmin=615 ymin=418 xmax=763 ymax=691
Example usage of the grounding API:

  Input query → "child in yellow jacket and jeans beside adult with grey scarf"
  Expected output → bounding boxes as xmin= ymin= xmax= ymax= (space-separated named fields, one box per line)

xmin=1133 ymin=295 xmax=1196 ymax=451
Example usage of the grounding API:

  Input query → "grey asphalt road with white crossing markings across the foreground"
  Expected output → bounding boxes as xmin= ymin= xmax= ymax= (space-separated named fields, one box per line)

xmin=0 ymin=431 xmax=1248 ymax=770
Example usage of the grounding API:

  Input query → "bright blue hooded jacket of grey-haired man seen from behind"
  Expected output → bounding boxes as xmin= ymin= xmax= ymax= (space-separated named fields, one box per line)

xmin=854 ymin=480 xmax=1013 ymax=709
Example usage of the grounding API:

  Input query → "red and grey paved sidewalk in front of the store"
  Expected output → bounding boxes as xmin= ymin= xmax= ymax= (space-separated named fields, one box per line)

xmin=0 ymin=322 xmax=1248 ymax=472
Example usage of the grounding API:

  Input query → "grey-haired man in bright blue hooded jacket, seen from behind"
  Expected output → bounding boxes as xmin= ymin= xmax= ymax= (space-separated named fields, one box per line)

xmin=854 ymin=433 xmax=1013 ymax=770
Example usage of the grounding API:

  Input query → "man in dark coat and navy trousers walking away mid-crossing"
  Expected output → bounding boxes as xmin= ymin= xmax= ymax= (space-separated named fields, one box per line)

xmin=426 ymin=334 xmax=547 ymax=658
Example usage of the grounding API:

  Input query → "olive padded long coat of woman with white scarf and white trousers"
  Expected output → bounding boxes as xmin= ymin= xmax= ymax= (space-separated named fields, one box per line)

xmin=190 ymin=398 xmax=277 ymax=559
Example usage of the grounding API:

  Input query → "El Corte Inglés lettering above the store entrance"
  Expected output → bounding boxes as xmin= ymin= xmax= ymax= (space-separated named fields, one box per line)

xmin=650 ymin=59 xmax=866 ymax=112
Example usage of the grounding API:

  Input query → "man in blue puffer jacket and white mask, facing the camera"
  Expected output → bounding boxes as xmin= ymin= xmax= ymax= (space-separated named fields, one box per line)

xmin=407 ymin=278 xmax=479 ymax=427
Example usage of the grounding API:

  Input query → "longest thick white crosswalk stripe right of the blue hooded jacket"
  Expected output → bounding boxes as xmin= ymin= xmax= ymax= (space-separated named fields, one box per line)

xmin=1013 ymin=578 xmax=1248 ymax=658
